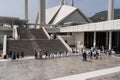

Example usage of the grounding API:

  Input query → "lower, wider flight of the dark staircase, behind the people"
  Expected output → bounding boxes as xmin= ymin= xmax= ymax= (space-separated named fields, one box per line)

xmin=8 ymin=39 xmax=67 ymax=56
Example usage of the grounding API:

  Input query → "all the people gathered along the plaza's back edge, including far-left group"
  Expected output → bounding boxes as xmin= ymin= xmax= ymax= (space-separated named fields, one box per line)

xmin=4 ymin=49 xmax=113 ymax=62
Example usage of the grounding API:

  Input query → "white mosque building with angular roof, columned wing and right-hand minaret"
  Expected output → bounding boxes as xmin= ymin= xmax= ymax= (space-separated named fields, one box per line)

xmin=35 ymin=0 xmax=120 ymax=50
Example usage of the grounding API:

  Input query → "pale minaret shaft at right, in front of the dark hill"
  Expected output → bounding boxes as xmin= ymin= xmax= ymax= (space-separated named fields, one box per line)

xmin=108 ymin=0 xmax=114 ymax=20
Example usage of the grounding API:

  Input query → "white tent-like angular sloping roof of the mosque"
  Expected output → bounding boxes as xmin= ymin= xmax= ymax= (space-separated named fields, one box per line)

xmin=37 ymin=5 xmax=91 ymax=25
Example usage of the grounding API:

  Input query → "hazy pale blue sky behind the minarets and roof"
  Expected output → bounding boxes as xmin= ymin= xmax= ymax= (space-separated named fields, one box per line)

xmin=0 ymin=0 xmax=120 ymax=22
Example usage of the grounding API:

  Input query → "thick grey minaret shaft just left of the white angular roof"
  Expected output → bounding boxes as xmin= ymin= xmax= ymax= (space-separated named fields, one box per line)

xmin=39 ymin=0 xmax=46 ymax=27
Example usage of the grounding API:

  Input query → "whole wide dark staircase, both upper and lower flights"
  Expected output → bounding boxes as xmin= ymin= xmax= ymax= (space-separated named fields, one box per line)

xmin=7 ymin=28 xmax=67 ymax=56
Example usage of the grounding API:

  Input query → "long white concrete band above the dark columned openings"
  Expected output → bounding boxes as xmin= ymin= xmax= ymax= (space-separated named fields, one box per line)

xmin=60 ymin=19 xmax=120 ymax=32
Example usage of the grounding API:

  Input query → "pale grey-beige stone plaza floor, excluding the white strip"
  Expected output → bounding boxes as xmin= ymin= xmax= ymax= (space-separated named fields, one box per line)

xmin=0 ymin=55 xmax=120 ymax=80
